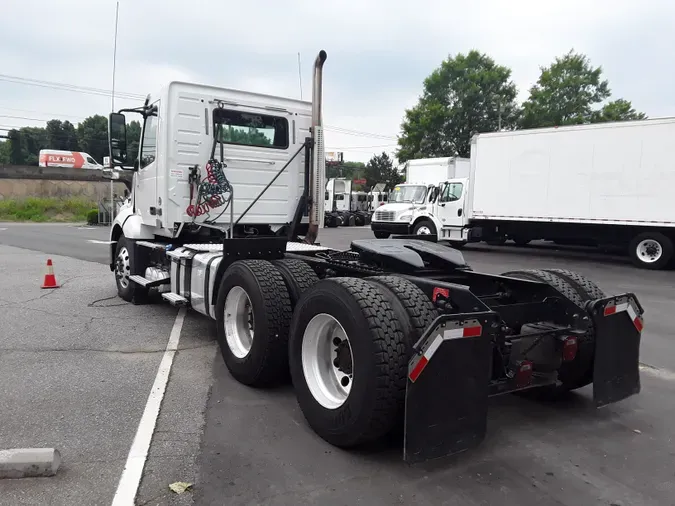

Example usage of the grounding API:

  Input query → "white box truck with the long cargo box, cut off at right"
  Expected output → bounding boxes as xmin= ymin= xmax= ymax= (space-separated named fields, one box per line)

xmin=412 ymin=118 xmax=675 ymax=269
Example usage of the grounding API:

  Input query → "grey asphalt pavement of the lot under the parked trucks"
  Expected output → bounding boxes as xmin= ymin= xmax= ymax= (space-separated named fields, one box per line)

xmin=0 ymin=224 xmax=675 ymax=506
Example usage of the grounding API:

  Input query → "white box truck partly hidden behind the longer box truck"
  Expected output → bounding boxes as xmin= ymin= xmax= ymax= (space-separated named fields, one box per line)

xmin=370 ymin=157 xmax=471 ymax=239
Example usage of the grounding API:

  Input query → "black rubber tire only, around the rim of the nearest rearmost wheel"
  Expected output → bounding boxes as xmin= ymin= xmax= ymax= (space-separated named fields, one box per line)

xmin=289 ymin=278 xmax=407 ymax=447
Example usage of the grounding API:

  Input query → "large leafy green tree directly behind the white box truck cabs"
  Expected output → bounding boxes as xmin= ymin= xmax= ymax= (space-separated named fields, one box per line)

xmin=396 ymin=50 xmax=519 ymax=162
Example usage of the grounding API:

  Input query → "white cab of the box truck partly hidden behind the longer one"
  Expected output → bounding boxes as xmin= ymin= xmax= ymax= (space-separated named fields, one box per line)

xmin=370 ymin=183 xmax=433 ymax=239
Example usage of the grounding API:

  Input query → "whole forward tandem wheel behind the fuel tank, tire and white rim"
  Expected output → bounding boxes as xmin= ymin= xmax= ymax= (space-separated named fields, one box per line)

xmin=216 ymin=260 xmax=292 ymax=386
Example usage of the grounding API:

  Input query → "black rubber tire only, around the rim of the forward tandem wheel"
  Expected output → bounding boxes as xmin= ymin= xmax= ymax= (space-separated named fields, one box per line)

xmin=216 ymin=260 xmax=292 ymax=387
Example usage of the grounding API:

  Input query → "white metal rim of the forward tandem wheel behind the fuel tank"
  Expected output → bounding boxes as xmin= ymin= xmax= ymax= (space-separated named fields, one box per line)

xmin=224 ymin=286 xmax=255 ymax=358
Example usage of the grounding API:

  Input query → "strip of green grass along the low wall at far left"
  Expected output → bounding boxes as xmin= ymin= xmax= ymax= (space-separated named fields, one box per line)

xmin=0 ymin=197 xmax=97 ymax=223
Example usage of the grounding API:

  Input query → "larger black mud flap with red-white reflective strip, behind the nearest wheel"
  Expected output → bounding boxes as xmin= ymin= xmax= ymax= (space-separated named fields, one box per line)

xmin=403 ymin=312 xmax=499 ymax=463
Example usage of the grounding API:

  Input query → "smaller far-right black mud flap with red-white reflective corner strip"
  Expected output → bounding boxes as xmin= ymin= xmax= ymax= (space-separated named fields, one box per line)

xmin=590 ymin=294 xmax=644 ymax=407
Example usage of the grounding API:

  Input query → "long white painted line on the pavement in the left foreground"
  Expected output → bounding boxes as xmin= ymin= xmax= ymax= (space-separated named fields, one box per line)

xmin=112 ymin=308 xmax=186 ymax=506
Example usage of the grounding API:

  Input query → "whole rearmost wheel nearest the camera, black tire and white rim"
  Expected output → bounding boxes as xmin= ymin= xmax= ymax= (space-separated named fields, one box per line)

xmin=289 ymin=278 xmax=407 ymax=447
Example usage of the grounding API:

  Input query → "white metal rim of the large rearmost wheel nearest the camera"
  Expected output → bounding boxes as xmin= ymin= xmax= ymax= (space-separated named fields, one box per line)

xmin=302 ymin=313 xmax=354 ymax=409
